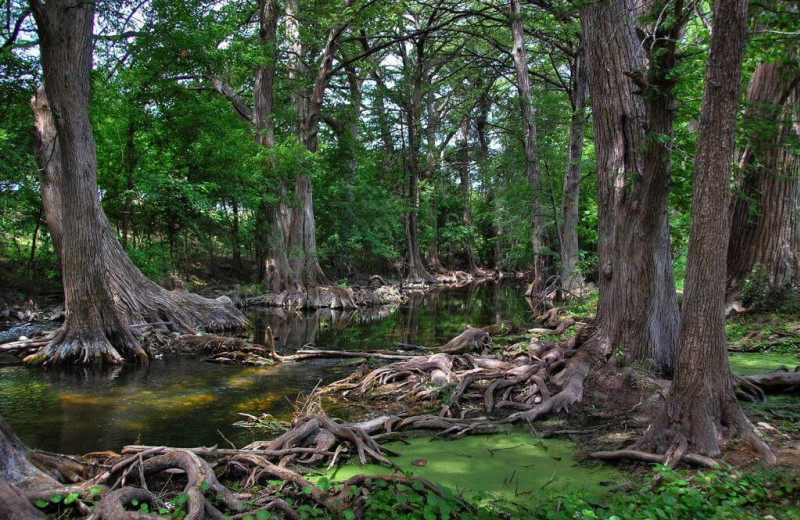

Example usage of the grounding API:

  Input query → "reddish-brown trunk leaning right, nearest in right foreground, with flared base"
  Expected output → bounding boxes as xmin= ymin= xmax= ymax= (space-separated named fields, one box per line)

xmin=645 ymin=0 xmax=774 ymax=463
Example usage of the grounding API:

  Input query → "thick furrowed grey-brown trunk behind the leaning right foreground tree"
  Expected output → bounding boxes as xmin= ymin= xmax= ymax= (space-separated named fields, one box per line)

xmin=581 ymin=0 xmax=679 ymax=372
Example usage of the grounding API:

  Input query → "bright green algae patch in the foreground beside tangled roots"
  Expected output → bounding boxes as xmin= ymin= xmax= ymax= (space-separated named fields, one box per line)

xmin=327 ymin=432 xmax=626 ymax=505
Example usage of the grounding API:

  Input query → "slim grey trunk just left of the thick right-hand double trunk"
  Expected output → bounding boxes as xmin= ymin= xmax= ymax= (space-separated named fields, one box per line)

xmin=561 ymin=54 xmax=589 ymax=292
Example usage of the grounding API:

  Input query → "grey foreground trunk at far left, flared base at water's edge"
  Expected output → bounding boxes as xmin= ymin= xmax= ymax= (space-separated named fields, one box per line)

xmin=31 ymin=0 xmax=147 ymax=365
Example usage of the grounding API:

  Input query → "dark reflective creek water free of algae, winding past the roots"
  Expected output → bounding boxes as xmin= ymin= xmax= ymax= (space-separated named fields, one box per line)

xmin=0 ymin=282 xmax=531 ymax=454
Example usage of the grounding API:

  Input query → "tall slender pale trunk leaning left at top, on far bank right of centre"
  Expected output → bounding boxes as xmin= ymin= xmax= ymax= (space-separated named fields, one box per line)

xmin=510 ymin=0 xmax=545 ymax=296
